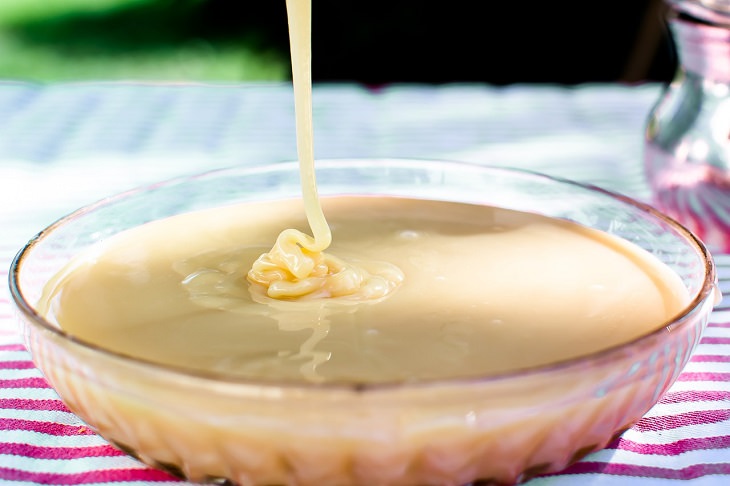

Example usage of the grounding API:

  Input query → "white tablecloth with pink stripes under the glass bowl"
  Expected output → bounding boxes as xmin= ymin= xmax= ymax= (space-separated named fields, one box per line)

xmin=0 ymin=83 xmax=730 ymax=486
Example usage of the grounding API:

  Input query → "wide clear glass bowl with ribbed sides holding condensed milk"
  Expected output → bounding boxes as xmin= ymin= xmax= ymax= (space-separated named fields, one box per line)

xmin=10 ymin=160 xmax=718 ymax=485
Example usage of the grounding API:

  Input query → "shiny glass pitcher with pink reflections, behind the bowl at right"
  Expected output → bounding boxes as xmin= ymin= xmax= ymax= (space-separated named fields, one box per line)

xmin=644 ymin=0 xmax=730 ymax=253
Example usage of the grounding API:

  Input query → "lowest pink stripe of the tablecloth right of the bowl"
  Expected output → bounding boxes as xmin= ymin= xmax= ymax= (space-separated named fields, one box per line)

xmin=560 ymin=461 xmax=730 ymax=480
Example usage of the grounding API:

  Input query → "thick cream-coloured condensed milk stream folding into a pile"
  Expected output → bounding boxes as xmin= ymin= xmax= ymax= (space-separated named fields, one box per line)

xmin=248 ymin=0 xmax=403 ymax=301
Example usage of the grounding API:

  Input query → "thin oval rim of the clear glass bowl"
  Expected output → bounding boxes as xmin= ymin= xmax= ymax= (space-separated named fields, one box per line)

xmin=8 ymin=158 xmax=717 ymax=393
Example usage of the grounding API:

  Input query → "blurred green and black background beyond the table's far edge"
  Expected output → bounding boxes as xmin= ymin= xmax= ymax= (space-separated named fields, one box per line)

xmin=0 ymin=0 xmax=676 ymax=85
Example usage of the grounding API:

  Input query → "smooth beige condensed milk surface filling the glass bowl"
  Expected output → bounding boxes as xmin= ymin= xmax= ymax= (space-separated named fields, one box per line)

xmin=41 ymin=196 xmax=689 ymax=383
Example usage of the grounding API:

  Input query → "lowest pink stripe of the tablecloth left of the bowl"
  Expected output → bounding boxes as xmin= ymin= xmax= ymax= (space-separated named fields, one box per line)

xmin=0 ymin=467 xmax=175 ymax=485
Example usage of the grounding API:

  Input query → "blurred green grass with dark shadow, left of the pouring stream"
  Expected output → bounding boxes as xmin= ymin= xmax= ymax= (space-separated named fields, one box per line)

xmin=0 ymin=0 xmax=290 ymax=82
